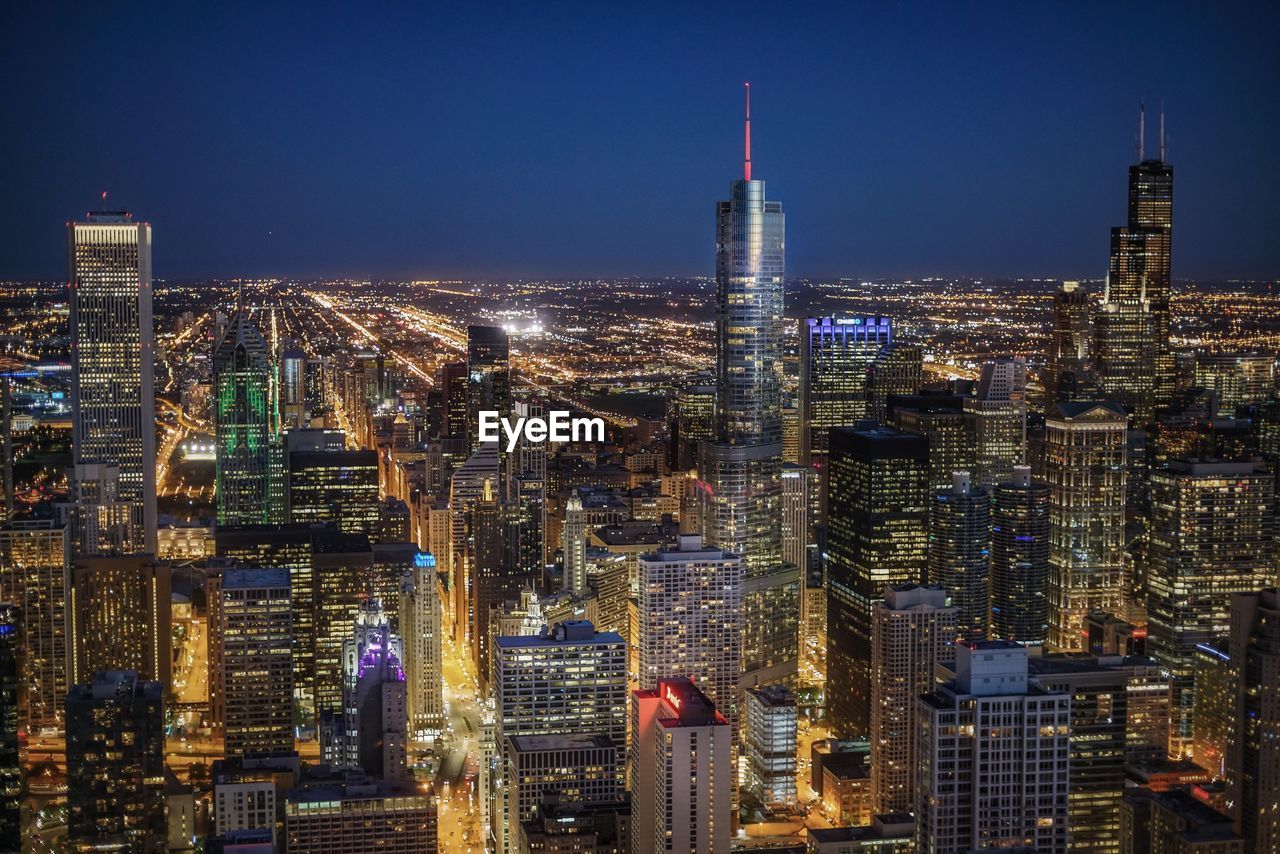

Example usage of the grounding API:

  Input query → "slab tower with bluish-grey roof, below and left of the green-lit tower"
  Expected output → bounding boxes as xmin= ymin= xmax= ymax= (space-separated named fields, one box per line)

xmin=218 ymin=567 xmax=293 ymax=757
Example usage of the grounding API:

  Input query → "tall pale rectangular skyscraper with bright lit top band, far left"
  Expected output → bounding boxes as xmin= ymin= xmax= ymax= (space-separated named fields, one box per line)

xmin=67 ymin=211 xmax=156 ymax=554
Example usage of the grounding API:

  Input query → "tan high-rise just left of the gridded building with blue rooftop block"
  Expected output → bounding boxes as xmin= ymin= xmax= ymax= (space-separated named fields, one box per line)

xmin=870 ymin=584 xmax=960 ymax=814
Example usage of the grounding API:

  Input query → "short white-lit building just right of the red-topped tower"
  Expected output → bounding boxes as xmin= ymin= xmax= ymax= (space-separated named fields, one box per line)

xmin=742 ymin=685 xmax=799 ymax=809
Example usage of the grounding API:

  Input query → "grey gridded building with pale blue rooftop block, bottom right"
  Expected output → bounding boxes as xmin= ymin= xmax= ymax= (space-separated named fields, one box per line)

xmin=915 ymin=640 xmax=1071 ymax=854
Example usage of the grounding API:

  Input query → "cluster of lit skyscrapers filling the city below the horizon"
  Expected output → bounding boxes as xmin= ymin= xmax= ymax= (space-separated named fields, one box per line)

xmin=0 ymin=93 xmax=1280 ymax=854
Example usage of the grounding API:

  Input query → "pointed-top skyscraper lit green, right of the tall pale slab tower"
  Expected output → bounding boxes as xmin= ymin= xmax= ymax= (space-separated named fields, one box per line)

xmin=214 ymin=307 xmax=284 ymax=525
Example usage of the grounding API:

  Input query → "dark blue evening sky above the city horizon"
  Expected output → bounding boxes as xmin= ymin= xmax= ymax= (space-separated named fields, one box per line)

xmin=0 ymin=0 xmax=1280 ymax=278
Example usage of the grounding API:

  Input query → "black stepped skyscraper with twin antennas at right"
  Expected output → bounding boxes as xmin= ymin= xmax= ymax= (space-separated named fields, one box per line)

xmin=1094 ymin=106 xmax=1174 ymax=424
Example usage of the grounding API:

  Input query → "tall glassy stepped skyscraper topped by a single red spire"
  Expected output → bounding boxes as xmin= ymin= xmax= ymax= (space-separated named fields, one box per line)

xmin=699 ymin=88 xmax=800 ymax=685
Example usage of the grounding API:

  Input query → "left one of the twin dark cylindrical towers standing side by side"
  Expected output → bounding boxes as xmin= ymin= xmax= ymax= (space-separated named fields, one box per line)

xmin=931 ymin=471 xmax=991 ymax=640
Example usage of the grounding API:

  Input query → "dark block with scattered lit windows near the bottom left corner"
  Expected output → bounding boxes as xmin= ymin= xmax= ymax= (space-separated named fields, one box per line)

xmin=67 ymin=671 xmax=168 ymax=854
